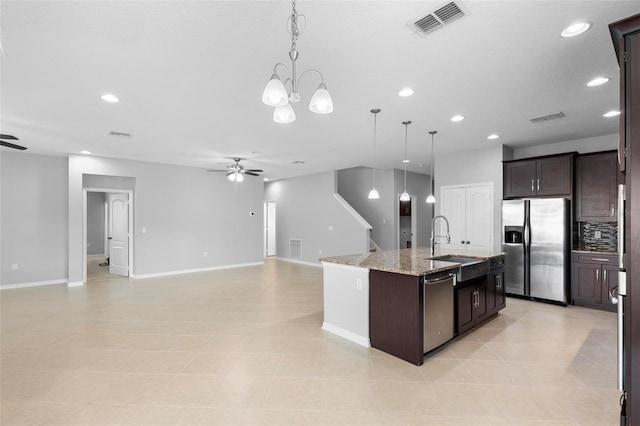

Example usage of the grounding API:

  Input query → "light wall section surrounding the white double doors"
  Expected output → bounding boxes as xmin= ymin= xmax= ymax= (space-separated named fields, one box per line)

xmin=434 ymin=145 xmax=503 ymax=251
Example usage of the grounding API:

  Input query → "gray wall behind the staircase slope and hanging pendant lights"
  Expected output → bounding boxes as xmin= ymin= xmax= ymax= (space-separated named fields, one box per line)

xmin=338 ymin=167 xmax=432 ymax=250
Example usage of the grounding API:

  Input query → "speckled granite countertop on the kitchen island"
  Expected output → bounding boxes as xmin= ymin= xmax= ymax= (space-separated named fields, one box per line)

xmin=320 ymin=247 xmax=504 ymax=276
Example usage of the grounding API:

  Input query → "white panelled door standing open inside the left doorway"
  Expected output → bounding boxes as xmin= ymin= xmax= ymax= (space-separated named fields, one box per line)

xmin=108 ymin=194 xmax=129 ymax=277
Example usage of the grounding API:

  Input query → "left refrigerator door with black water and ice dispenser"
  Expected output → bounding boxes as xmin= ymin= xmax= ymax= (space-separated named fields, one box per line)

xmin=502 ymin=200 xmax=525 ymax=296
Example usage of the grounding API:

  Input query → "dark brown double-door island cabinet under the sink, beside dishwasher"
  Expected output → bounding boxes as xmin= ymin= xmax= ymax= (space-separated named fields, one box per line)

xmin=456 ymin=277 xmax=490 ymax=334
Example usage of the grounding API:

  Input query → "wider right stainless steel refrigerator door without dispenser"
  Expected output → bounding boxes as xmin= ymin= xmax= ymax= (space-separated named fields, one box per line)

xmin=530 ymin=198 xmax=569 ymax=303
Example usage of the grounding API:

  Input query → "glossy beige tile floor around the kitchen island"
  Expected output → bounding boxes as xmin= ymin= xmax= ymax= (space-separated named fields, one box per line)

xmin=0 ymin=259 xmax=619 ymax=426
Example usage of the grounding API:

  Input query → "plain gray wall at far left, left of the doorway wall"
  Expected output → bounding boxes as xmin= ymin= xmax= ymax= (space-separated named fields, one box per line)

xmin=0 ymin=151 xmax=68 ymax=285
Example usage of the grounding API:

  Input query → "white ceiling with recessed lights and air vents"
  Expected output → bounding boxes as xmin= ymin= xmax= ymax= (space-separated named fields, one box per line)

xmin=0 ymin=0 xmax=640 ymax=179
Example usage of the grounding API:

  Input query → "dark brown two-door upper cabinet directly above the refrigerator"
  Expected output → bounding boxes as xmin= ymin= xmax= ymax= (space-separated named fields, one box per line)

xmin=503 ymin=154 xmax=574 ymax=198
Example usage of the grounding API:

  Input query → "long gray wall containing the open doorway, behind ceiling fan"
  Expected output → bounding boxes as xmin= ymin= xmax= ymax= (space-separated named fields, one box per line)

xmin=68 ymin=155 xmax=264 ymax=284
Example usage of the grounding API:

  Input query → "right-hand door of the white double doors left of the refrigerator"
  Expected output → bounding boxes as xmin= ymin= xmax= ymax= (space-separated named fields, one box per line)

xmin=464 ymin=185 xmax=493 ymax=254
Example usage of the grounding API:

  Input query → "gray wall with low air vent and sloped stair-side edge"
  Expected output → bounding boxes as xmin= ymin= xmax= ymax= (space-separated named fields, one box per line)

xmin=264 ymin=171 xmax=369 ymax=264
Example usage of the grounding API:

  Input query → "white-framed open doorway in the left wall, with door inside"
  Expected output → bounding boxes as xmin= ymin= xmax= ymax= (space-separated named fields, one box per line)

xmin=83 ymin=188 xmax=133 ymax=283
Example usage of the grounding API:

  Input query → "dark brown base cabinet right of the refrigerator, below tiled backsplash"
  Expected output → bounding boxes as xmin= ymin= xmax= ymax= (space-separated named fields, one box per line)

xmin=571 ymin=253 xmax=618 ymax=312
